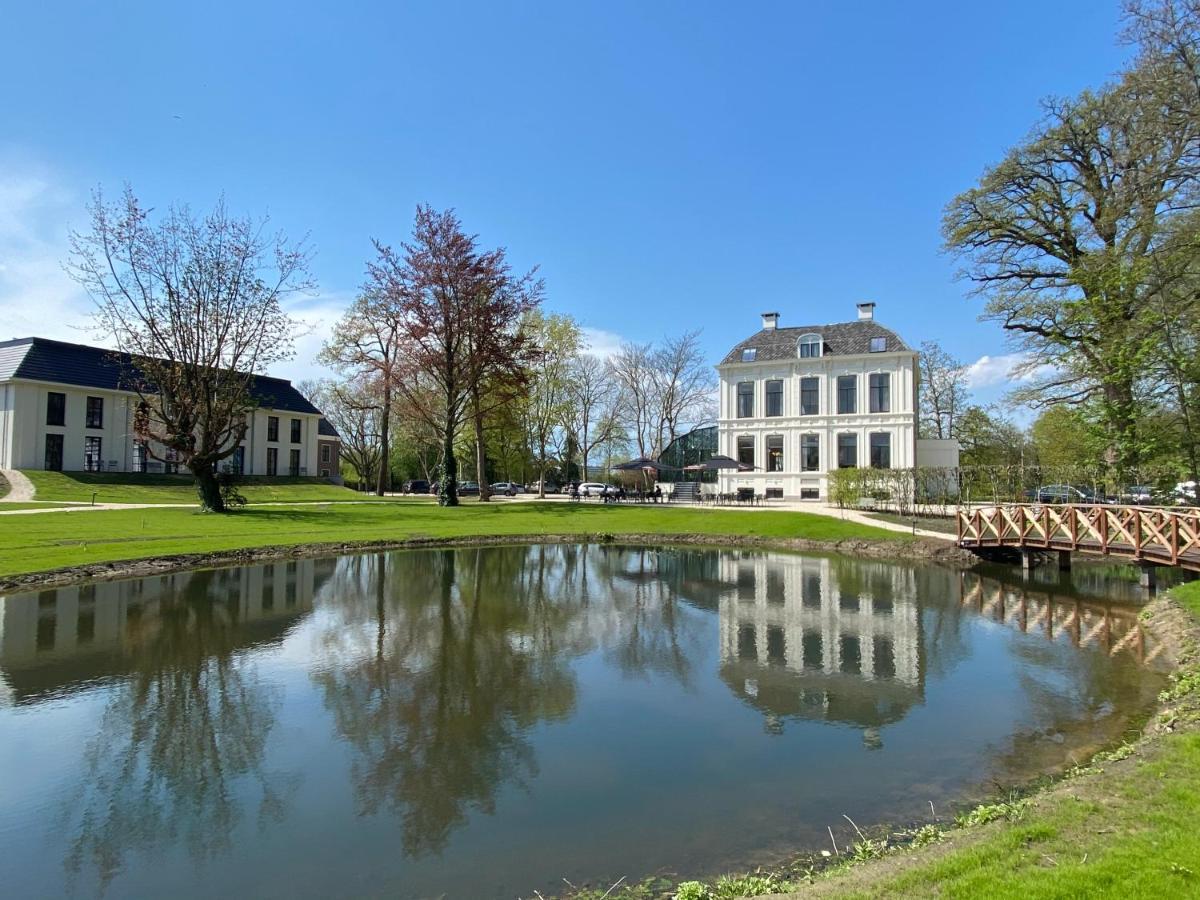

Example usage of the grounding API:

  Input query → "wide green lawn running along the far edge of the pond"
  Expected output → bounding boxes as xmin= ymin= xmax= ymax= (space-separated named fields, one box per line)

xmin=0 ymin=503 xmax=908 ymax=576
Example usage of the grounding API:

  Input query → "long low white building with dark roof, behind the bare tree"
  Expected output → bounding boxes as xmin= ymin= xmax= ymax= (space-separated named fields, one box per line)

xmin=0 ymin=337 xmax=340 ymax=478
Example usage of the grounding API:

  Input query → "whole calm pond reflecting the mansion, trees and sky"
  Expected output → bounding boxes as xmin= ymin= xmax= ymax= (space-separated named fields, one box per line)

xmin=0 ymin=545 xmax=1164 ymax=898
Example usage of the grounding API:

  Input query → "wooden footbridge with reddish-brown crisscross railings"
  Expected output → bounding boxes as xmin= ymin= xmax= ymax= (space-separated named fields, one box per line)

xmin=958 ymin=503 xmax=1200 ymax=573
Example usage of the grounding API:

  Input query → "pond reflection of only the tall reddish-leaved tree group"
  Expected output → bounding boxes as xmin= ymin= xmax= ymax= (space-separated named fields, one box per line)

xmin=314 ymin=548 xmax=575 ymax=853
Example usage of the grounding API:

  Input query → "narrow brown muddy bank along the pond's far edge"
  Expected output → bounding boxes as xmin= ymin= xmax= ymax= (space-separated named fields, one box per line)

xmin=0 ymin=532 xmax=976 ymax=593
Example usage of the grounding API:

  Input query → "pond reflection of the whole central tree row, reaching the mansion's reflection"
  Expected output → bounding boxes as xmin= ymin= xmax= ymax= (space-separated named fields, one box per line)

xmin=313 ymin=545 xmax=702 ymax=854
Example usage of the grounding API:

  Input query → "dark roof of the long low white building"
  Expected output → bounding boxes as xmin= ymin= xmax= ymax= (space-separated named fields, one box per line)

xmin=0 ymin=337 xmax=320 ymax=415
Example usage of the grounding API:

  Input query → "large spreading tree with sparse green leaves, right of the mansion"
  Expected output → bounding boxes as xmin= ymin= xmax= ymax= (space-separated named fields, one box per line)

xmin=944 ymin=2 xmax=1200 ymax=469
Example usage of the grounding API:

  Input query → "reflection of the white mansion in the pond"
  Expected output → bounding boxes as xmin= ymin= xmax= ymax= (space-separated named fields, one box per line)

xmin=720 ymin=554 xmax=924 ymax=726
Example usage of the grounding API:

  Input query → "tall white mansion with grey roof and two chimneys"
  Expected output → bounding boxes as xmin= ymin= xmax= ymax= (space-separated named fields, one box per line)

xmin=716 ymin=302 xmax=959 ymax=499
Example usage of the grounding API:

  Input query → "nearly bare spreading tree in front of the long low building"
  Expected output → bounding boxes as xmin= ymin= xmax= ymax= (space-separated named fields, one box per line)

xmin=67 ymin=187 xmax=312 ymax=512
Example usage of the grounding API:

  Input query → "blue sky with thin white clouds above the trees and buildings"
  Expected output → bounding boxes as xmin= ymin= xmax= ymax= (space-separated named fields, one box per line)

xmin=0 ymin=0 xmax=1128 ymax=408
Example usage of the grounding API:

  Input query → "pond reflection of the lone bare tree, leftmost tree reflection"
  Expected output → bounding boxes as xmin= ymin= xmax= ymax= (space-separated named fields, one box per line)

xmin=62 ymin=564 xmax=311 ymax=887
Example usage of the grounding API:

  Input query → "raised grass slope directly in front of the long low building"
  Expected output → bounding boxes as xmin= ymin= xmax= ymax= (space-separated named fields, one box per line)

xmin=23 ymin=469 xmax=403 ymax=504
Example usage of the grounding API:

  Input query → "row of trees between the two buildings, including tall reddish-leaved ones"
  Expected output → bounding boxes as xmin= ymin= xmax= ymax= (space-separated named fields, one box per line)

xmin=314 ymin=206 xmax=715 ymax=505
